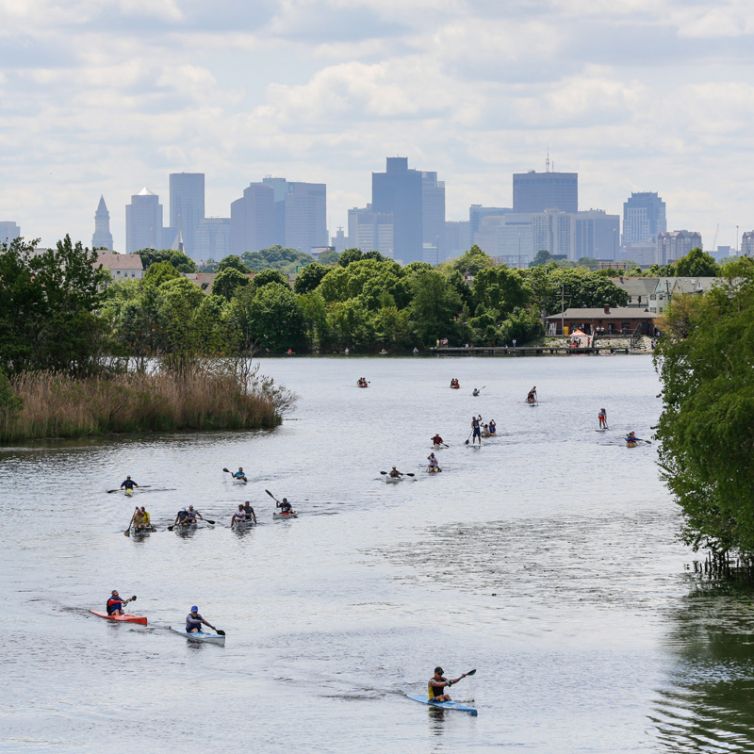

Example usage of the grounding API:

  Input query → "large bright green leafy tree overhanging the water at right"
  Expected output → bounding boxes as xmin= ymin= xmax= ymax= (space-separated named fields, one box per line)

xmin=656 ymin=276 xmax=754 ymax=558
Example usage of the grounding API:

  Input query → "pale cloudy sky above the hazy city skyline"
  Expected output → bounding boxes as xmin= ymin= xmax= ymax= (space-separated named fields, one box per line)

xmin=0 ymin=0 xmax=754 ymax=249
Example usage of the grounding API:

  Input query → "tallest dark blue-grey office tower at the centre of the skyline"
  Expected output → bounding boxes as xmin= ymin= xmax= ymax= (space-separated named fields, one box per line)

xmin=372 ymin=157 xmax=424 ymax=264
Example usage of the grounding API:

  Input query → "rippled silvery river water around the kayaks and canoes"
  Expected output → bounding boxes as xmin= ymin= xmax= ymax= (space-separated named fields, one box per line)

xmin=0 ymin=357 xmax=754 ymax=754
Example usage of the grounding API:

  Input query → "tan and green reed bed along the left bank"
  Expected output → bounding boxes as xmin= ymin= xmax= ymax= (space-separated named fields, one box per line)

xmin=0 ymin=368 xmax=281 ymax=442
